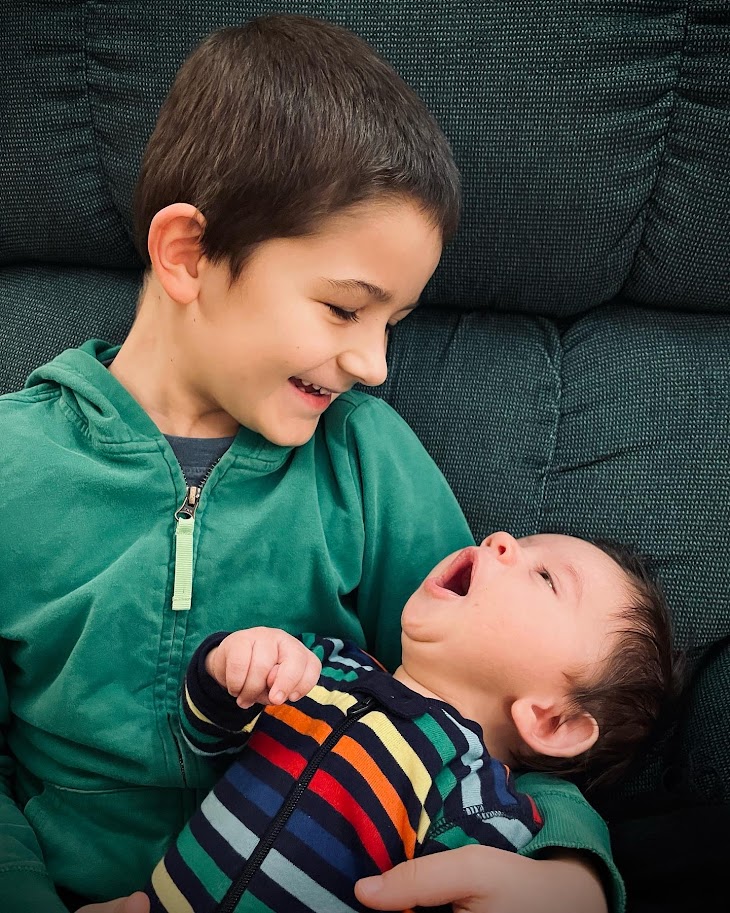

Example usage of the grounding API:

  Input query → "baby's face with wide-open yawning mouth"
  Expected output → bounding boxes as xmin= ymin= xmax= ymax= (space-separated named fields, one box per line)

xmin=402 ymin=532 xmax=630 ymax=712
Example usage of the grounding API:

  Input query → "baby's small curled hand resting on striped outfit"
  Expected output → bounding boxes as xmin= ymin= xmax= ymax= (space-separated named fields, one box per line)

xmin=205 ymin=628 xmax=322 ymax=708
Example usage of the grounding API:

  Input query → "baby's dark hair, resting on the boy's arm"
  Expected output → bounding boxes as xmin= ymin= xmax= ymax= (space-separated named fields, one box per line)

xmin=516 ymin=540 xmax=683 ymax=790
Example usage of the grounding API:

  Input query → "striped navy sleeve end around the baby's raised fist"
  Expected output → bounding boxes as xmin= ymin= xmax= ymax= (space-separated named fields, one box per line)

xmin=180 ymin=631 xmax=263 ymax=757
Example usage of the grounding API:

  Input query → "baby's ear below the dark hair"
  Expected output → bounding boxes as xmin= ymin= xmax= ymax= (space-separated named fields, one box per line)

xmin=511 ymin=697 xmax=598 ymax=758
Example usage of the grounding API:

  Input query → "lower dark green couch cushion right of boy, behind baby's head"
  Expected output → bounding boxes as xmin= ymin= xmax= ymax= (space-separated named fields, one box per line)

xmin=376 ymin=301 xmax=730 ymax=804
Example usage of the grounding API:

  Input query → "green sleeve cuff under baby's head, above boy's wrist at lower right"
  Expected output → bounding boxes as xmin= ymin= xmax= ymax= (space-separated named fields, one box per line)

xmin=517 ymin=773 xmax=626 ymax=913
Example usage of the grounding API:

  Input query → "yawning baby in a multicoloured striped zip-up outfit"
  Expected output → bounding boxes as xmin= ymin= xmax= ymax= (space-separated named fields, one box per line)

xmin=148 ymin=532 xmax=673 ymax=913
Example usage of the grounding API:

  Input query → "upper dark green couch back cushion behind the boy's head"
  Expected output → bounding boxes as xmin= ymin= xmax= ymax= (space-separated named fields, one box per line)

xmin=0 ymin=0 xmax=730 ymax=315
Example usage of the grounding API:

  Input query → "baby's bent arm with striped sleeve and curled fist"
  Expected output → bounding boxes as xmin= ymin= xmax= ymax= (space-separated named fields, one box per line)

xmin=180 ymin=628 xmax=321 ymax=755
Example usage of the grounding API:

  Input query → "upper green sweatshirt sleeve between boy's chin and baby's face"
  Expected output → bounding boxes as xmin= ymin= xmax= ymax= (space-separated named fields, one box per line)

xmin=347 ymin=397 xmax=474 ymax=671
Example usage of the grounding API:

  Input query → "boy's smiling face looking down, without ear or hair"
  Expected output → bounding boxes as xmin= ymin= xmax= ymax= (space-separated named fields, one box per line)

xmin=179 ymin=201 xmax=441 ymax=446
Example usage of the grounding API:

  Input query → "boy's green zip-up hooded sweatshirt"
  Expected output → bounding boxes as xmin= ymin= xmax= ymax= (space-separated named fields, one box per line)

xmin=0 ymin=341 xmax=623 ymax=913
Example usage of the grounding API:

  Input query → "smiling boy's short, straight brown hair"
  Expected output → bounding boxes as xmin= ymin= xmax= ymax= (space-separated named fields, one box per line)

xmin=134 ymin=15 xmax=460 ymax=280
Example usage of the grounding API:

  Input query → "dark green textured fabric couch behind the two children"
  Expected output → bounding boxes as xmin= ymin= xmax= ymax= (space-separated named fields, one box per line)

xmin=0 ymin=0 xmax=730 ymax=913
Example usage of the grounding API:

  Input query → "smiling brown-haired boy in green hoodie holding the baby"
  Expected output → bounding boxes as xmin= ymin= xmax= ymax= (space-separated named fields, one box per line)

xmin=0 ymin=16 xmax=623 ymax=913
